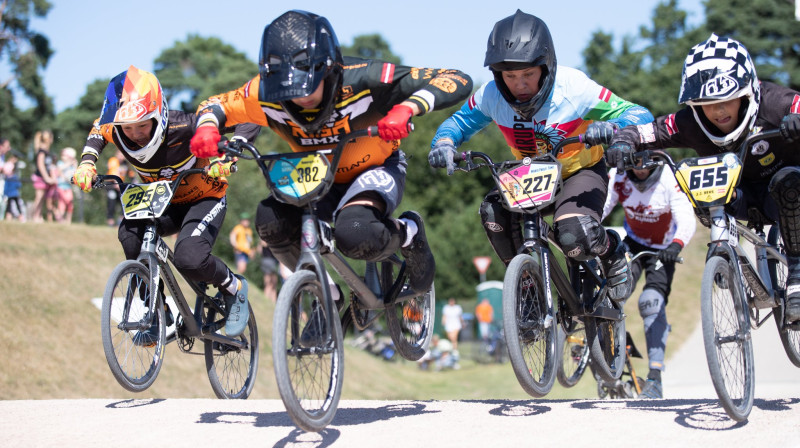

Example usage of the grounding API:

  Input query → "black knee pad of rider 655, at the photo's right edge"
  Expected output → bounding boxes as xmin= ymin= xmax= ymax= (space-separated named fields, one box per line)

xmin=768 ymin=166 xmax=800 ymax=256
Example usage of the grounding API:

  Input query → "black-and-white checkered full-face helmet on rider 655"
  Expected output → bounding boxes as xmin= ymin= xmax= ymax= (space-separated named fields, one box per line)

xmin=678 ymin=33 xmax=761 ymax=149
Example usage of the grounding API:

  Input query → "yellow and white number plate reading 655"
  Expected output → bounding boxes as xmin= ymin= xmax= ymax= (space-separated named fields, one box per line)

xmin=675 ymin=153 xmax=742 ymax=208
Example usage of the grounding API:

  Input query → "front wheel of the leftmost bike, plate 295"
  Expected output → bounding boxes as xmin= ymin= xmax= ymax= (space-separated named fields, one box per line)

xmin=100 ymin=260 xmax=166 ymax=392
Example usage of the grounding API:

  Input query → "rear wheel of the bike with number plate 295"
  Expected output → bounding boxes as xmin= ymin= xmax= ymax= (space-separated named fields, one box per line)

xmin=204 ymin=303 xmax=259 ymax=400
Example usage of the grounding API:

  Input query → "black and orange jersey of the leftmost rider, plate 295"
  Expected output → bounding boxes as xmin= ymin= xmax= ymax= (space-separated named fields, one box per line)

xmin=81 ymin=110 xmax=260 ymax=204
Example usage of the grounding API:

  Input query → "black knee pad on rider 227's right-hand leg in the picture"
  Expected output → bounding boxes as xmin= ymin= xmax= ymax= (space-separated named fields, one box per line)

xmin=553 ymin=215 xmax=609 ymax=261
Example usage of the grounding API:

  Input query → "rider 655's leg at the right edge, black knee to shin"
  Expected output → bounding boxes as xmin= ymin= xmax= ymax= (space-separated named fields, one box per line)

xmin=768 ymin=167 xmax=800 ymax=322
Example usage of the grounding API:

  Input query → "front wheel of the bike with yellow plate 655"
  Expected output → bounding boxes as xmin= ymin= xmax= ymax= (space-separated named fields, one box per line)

xmin=700 ymin=256 xmax=755 ymax=421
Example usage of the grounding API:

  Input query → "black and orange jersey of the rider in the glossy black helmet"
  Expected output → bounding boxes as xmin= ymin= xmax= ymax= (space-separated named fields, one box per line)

xmin=197 ymin=57 xmax=472 ymax=183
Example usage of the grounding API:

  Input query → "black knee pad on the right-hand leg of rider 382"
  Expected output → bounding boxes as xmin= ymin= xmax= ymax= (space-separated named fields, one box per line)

xmin=333 ymin=205 xmax=405 ymax=261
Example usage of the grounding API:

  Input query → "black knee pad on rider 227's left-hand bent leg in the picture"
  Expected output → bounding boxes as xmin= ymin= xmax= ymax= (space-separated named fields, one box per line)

xmin=479 ymin=190 xmax=522 ymax=266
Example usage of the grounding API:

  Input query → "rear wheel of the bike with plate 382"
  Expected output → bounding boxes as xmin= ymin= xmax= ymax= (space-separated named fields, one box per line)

xmin=381 ymin=262 xmax=436 ymax=361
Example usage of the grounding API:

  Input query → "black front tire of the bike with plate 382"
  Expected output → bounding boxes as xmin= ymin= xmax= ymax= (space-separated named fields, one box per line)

xmin=272 ymin=270 xmax=344 ymax=432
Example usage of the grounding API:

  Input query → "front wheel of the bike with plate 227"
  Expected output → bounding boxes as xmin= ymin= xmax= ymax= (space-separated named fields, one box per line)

xmin=503 ymin=254 xmax=557 ymax=397
